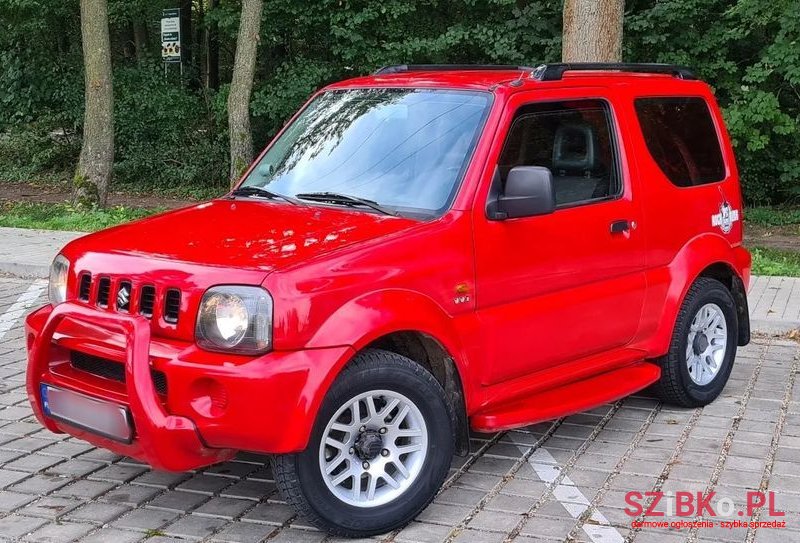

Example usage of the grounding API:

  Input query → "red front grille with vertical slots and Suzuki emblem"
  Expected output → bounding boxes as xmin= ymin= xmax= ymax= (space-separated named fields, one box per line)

xmin=77 ymin=272 xmax=182 ymax=324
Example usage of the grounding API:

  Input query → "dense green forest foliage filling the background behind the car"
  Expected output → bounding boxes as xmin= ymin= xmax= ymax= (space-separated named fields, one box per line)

xmin=0 ymin=0 xmax=800 ymax=205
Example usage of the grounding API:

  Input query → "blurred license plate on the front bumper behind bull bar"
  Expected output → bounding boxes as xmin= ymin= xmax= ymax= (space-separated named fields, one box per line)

xmin=40 ymin=384 xmax=133 ymax=443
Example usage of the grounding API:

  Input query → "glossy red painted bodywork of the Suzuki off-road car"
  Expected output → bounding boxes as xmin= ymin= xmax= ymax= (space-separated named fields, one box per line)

xmin=26 ymin=71 xmax=750 ymax=469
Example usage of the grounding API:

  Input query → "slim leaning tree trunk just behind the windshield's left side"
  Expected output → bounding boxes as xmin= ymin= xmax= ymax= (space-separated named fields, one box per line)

xmin=228 ymin=0 xmax=264 ymax=184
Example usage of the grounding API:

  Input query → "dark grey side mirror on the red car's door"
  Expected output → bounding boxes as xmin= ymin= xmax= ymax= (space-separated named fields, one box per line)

xmin=491 ymin=166 xmax=556 ymax=220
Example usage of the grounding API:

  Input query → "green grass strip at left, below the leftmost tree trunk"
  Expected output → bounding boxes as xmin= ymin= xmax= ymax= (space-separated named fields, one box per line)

xmin=0 ymin=202 xmax=162 ymax=232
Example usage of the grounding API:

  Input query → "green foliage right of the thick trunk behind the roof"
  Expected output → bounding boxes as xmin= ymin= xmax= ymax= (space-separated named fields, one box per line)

xmin=625 ymin=0 xmax=800 ymax=204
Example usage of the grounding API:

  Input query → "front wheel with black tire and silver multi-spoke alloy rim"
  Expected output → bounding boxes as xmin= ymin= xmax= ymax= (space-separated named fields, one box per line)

xmin=273 ymin=350 xmax=455 ymax=537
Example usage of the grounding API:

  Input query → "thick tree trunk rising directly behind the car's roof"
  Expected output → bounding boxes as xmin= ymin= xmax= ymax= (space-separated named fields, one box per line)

xmin=561 ymin=0 xmax=625 ymax=62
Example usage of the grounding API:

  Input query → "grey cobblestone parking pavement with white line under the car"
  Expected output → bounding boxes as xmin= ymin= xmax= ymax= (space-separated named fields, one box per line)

xmin=0 ymin=279 xmax=800 ymax=543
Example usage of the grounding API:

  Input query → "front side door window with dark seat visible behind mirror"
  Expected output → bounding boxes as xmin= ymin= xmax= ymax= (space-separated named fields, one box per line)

xmin=498 ymin=100 xmax=621 ymax=207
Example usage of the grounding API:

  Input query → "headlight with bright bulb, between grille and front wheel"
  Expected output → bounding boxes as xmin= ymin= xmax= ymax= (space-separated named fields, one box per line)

xmin=195 ymin=285 xmax=272 ymax=354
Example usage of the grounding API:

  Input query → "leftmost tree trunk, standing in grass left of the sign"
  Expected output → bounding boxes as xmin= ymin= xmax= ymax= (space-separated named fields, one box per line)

xmin=73 ymin=0 xmax=114 ymax=207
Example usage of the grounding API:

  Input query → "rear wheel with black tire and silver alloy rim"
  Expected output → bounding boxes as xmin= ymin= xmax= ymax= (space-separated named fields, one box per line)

xmin=654 ymin=277 xmax=739 ymax=407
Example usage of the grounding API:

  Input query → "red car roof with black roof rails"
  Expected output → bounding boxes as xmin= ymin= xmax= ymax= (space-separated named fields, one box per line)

xmin=326 ymin=64 xmax=708 ymax=91
